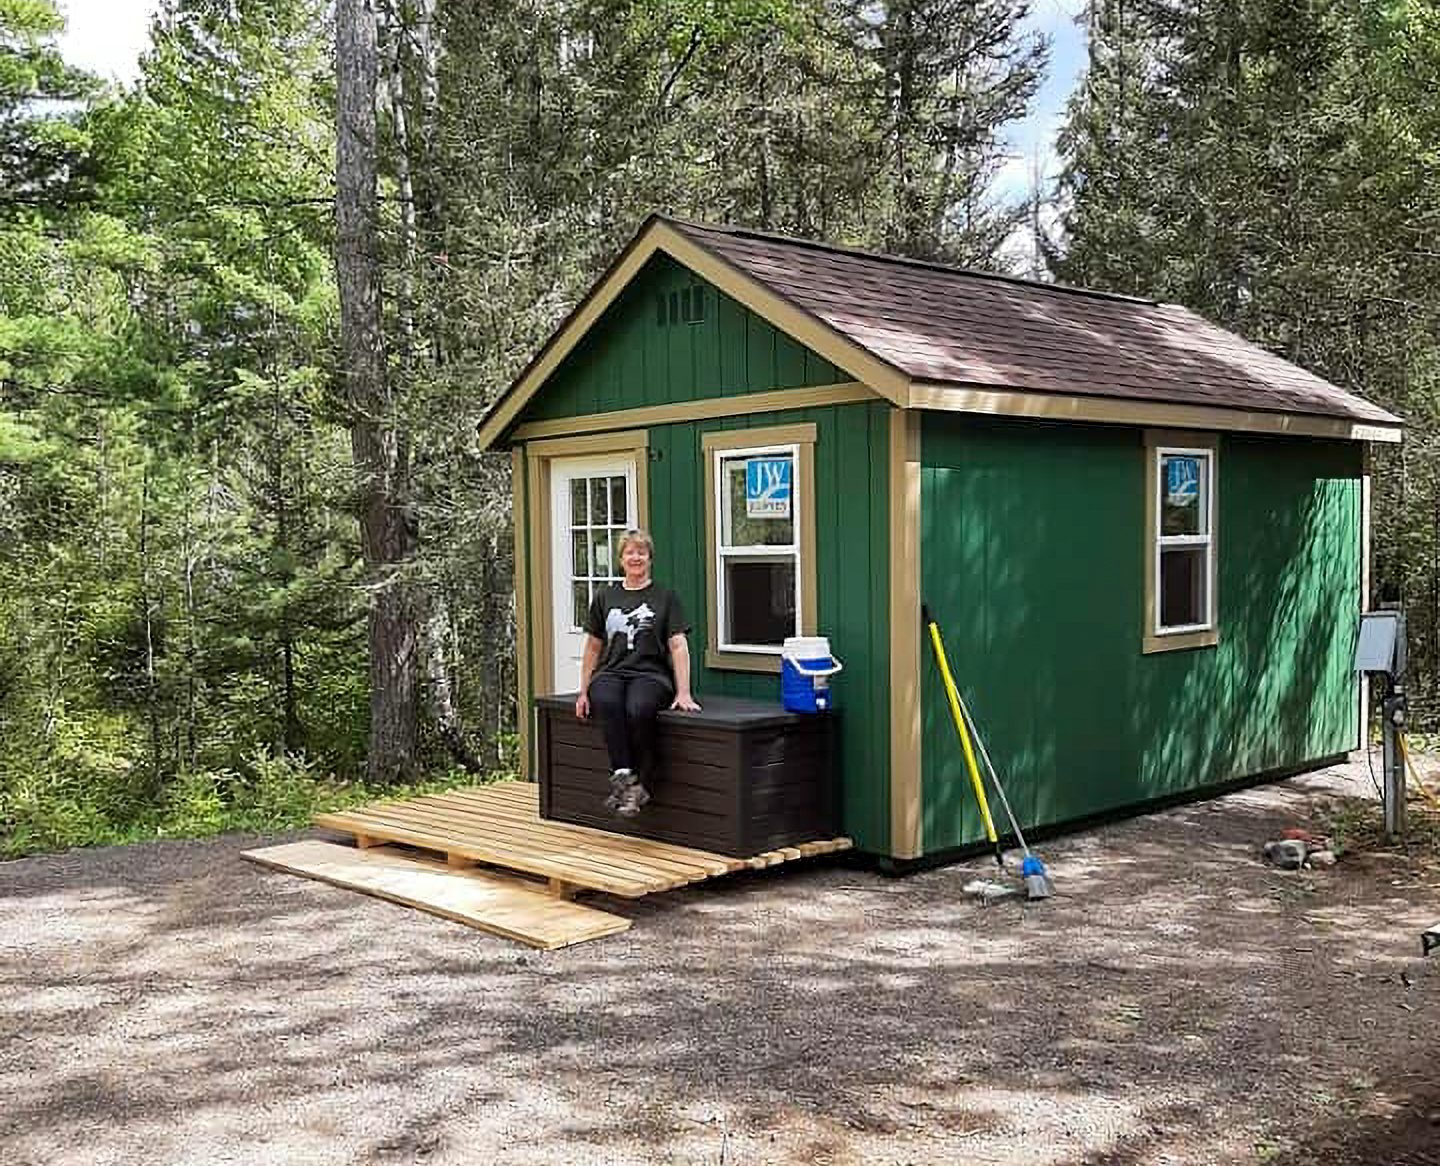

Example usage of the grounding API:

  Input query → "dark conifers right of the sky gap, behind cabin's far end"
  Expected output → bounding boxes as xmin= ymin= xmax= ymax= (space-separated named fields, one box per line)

xmin=1053 ymin=0 xmax=1440 ymax=724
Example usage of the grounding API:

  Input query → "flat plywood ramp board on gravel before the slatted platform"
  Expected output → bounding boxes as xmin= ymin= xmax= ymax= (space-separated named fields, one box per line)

xmin=243 ymin=841 xmax=629 ymax=950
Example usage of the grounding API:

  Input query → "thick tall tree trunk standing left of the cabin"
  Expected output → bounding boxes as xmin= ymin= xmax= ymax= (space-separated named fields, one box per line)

xmin=336 ymin=0 xmax=419 ymax=782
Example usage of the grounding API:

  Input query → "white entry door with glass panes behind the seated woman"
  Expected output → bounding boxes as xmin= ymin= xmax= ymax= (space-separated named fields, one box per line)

xmin=550 ymin=453 xmax=638 ymax=692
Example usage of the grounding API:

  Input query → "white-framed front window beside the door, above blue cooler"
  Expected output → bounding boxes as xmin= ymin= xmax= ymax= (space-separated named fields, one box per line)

xmin=711 ymin=443 xmax=802 ymax=655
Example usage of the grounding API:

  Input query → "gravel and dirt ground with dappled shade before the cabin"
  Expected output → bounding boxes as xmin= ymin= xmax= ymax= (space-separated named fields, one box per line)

xmin=0 ymin=763 xmax=1440 ymax=1166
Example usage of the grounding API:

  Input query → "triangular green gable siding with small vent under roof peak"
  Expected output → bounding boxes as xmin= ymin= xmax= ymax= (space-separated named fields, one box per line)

xmin=518 ymin=255 xmax=851 ymax=422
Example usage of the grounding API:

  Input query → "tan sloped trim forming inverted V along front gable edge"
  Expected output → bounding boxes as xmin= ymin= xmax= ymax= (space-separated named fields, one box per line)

xmin=478 ymin=217 xmax=910 ymax=449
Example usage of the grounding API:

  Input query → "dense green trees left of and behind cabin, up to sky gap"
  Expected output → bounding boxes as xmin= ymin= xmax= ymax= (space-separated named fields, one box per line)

xmin=0 ymin=0 xmax=1041 ymax=855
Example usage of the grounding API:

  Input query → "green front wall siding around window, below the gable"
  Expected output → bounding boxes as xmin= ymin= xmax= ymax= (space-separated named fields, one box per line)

xmin=649 ymin=403 xmax=890 ymax=852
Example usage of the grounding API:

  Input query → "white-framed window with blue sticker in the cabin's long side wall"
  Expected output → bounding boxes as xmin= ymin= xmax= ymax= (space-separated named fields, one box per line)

xmin=1149 ymin=445 xmax=1215 ymax=636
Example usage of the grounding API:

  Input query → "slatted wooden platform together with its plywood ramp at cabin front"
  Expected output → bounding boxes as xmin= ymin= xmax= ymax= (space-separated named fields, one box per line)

xmin=243 ymin=782 xmax=852 ymax=949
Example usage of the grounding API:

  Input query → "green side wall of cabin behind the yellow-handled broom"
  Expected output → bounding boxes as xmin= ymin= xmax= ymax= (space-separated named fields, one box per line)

xmin=922 ymin=415 xmax=1361 ymax=851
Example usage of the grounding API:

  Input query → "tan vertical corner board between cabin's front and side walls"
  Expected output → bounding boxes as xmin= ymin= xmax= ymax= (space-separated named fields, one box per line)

xmin=888 ymin=409 xmax=924 ymax=858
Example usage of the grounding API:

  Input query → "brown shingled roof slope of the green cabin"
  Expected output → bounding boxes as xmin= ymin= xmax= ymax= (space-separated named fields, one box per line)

xmin=665 ymin=219 xmax=1400 ymax=425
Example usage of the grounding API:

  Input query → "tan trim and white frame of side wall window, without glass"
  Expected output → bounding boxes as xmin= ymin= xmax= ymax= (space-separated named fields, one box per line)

xmin=1143 ymin=433 xmax=1220 ymax=652
